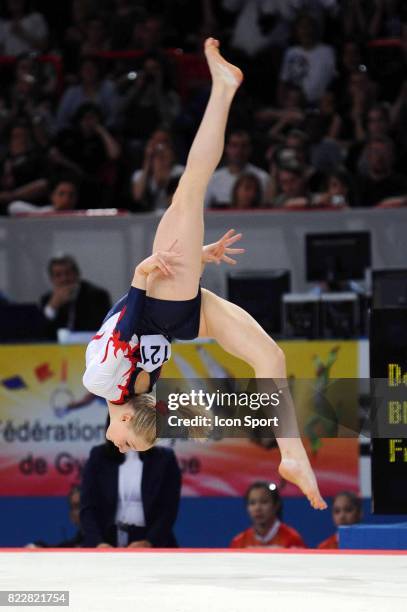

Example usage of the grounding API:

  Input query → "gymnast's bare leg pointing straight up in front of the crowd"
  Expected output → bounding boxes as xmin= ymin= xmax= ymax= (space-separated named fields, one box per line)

xmin=147 ymin=38 xmax=243 ymax=301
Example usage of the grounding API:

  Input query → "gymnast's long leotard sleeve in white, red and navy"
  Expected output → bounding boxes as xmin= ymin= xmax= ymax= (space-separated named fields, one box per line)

xmin=83 ymin=287 xmax=145 ymax=404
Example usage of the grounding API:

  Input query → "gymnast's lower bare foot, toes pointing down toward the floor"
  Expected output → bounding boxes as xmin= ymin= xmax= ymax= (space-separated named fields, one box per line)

xmin=278 ymin=451 xmax=327 ymax=510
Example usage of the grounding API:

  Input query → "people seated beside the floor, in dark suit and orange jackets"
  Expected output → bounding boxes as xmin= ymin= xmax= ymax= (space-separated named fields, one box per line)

xmin=26 ymin=470 xmax=363 ymax=550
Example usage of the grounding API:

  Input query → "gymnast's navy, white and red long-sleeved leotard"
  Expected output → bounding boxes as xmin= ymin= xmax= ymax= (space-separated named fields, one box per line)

xmin=83 ymin=287 xmax=201 ymax=404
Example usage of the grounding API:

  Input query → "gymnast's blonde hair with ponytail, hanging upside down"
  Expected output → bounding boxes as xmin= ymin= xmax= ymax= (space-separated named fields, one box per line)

xmin=130 ymin=393 xmax=210 ymax=446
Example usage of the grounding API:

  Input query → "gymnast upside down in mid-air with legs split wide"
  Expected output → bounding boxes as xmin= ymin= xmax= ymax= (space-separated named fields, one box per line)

xmin=83 ymin=38 xmax=326 ymax=510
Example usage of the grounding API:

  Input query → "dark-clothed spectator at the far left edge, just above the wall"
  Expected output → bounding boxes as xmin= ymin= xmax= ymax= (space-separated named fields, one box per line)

xmin=0 ymin=122 xmax=48 ymax=213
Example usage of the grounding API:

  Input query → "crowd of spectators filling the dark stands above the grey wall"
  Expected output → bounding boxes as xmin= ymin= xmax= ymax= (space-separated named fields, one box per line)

xmin=0 ymin=0 xmax=407 ymax=215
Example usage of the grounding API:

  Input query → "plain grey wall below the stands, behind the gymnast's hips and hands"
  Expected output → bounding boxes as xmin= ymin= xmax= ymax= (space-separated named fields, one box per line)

xmin=0 ymin=209 xmax=407 ymax=301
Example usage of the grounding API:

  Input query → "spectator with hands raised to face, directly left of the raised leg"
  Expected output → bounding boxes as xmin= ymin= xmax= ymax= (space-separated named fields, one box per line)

xmin=132 ymin=136 xmax=184 ymax=211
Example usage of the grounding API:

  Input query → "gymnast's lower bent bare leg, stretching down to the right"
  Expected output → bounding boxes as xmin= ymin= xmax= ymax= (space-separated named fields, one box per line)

xmin=200 ymin=289 xmax=326 ymax=510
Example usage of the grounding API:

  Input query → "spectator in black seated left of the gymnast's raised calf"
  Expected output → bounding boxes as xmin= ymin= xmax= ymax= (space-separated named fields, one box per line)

xmin=120 ymin=55 xmax=180 ymax=142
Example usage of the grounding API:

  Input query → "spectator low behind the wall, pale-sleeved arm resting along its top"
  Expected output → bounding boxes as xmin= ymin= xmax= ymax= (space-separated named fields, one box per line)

xmin=8 ymin=176 xmax=78 ymax=217
